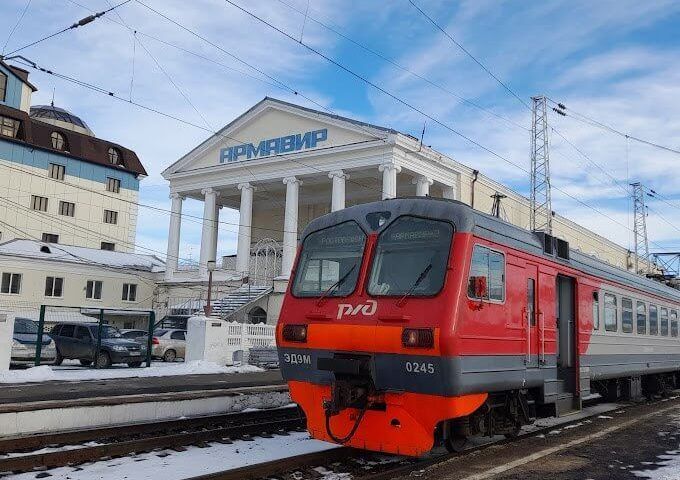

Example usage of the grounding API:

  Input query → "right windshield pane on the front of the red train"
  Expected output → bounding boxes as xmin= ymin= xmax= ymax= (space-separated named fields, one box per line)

xmin=368 ymin=216 xmax=453 ymax=296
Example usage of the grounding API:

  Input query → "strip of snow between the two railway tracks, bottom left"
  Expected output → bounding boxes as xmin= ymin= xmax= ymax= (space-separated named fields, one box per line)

xmin=6 ymin=432 xmax=341 ymax=480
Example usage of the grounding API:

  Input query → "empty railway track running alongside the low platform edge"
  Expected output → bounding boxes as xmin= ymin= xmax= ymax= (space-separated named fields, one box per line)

xmin=0 ymin=408 xmax=305 ymax=476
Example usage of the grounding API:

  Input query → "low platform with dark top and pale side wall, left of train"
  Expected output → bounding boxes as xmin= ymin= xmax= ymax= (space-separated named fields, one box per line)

xmin=0 ymin=370 xmax=290 ymax=437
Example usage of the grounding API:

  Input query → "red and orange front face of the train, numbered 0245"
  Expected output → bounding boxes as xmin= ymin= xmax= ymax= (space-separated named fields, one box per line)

xmin=277 ymin=212 xmax=487 ymax=455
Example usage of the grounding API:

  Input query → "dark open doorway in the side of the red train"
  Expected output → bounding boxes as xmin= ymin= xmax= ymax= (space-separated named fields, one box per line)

xmin=555 ymin=275 xmax=576 ymax=390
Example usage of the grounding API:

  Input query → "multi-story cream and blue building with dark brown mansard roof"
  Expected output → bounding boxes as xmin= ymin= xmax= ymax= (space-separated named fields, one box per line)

xmin=0 ymin=61 xmax=146 ymax=252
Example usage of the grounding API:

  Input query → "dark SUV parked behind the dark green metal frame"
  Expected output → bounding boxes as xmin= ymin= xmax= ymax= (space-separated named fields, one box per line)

xmin=50 ymin=322 xmax=146 ymax=368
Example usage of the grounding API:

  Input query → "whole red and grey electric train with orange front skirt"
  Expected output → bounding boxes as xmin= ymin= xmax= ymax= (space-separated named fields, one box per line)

xmin=277 ymin=198 xmax=680 ymax=455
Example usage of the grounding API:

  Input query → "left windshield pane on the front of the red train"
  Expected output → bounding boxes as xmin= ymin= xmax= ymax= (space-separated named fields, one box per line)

xmin=293 ymin=222 xmax=366 ymax=297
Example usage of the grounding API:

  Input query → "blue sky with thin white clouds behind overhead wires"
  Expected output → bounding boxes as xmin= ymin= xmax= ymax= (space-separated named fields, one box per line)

xmin=0 ymin=0 xmax=680 ymax=259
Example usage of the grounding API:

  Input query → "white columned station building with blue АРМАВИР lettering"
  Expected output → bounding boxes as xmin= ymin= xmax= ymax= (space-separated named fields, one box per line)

xmin=161 ymin=98 xmax=631 ymax=323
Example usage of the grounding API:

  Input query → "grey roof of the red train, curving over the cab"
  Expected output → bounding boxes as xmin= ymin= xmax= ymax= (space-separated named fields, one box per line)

xmin=302 ymin=197 xmax=680 ymax=302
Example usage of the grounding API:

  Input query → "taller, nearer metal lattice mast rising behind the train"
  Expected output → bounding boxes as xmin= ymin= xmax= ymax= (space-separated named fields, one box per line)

xmin=530 ymin=95 xmax=552 ymax=235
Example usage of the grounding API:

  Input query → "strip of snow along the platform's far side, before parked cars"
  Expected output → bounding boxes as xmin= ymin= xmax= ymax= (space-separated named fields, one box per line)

xmin=0 ymin=360 xmax=263 ymax=384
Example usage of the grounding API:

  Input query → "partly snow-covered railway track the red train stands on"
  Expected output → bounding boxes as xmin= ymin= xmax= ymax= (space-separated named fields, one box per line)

xmin=183 ymin=393 xmax=677 ymax=480
